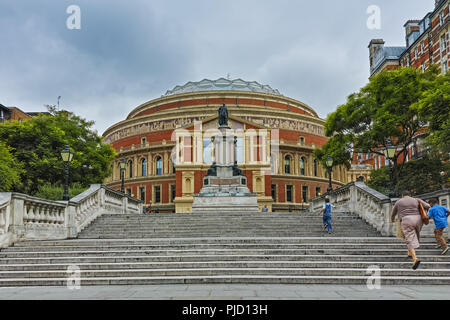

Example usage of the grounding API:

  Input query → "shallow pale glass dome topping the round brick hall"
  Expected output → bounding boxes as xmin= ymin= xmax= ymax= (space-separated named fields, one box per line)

xmin=164 ymin=78 xmax=282 ymax=96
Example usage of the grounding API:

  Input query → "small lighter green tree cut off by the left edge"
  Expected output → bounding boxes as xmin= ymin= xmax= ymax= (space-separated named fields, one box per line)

xmin=0 ymin=141 xmax=22 ymax=192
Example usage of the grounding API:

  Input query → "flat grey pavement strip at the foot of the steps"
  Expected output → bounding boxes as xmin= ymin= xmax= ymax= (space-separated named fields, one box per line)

xmin=0 ymin=284 xmax=450 ymax=300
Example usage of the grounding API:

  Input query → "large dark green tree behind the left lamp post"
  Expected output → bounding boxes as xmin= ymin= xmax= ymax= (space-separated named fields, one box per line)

xmin=0 ymin=106 xmax=115 ymax=195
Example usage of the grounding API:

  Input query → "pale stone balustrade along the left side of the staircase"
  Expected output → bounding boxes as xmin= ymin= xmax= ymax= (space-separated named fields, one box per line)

xmin=0 ymin=184 xmax=142 ymax=247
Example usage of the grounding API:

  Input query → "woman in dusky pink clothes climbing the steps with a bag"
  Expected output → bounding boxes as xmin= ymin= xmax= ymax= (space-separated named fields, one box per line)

xmin=391 ymin=191 xmax=430 ymax=270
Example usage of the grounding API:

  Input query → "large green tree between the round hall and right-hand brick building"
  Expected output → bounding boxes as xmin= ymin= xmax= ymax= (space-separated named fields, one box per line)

xmin=315 ymin=67 xmax=438 ymax=175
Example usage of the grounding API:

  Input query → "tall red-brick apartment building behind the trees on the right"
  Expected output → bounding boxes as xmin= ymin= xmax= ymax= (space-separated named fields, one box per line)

xmin=348 ymin=0 xmax=450 ymax=181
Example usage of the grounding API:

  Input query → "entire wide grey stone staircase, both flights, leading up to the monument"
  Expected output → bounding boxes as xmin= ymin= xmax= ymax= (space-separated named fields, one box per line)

xmin=0 ymin=212 xmax=450 ymax=286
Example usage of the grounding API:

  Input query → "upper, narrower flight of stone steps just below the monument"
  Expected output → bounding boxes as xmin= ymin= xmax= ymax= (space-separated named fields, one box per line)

xmin=79 ymin=212 xmax=380 ymax=239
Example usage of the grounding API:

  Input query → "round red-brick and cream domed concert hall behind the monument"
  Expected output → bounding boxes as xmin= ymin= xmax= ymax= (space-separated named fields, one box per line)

xmin=103 ymin=78 xmax=347 ymax=213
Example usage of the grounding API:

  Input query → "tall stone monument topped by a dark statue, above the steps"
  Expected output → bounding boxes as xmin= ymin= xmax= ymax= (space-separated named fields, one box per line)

xmin=192 ymin=105 xmax=258 ymax=213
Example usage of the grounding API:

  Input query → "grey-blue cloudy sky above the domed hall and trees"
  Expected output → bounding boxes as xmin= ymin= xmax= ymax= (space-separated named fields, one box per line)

xmin=0 ymin=0 xmax=434 ymax=134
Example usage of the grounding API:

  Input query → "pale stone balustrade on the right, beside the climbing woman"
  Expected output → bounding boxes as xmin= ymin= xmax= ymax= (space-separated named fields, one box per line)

xmin=310 ymin=181 xmax=396 ymax=236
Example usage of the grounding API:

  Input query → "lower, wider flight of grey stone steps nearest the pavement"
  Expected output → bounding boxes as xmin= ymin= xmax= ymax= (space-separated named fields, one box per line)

xmin=0 ymin=237 xmax=450 ymax=286
